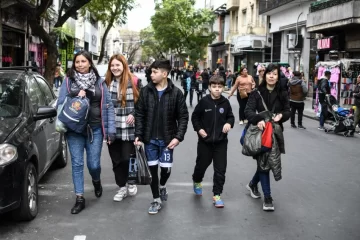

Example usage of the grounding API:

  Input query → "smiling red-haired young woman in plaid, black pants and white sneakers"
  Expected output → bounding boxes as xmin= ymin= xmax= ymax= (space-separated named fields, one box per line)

xmin=105 ymin=54 xmax=141 ymax=202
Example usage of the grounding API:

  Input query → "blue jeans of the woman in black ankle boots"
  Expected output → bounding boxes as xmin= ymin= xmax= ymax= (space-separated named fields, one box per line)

xmin=66 ymin=127 xmax=103 ymax=195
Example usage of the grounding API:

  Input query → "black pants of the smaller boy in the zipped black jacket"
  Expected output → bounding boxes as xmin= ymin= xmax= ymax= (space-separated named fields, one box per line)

xmin=193 ymin=140 xmax=228 ymax=196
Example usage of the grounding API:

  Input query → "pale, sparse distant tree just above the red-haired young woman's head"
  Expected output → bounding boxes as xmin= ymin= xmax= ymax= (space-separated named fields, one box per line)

xmin=120 ymin=29 xmax=141 ymax=64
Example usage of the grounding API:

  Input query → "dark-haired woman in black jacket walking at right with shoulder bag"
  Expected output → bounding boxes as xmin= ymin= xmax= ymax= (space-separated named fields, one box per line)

xmin=245 ymin=64 xmax=291 ymax=211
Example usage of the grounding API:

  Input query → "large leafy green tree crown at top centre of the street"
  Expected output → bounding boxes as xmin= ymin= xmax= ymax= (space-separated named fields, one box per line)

xmin=151 ymin=0 xmax=217 ymax=63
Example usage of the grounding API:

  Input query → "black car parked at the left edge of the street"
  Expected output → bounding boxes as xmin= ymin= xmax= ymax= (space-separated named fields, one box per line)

xmin=0 ymin=68 xmax=67 ymax=220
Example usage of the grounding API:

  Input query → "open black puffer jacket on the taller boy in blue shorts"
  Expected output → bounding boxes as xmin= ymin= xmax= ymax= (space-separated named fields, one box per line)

xmin=135 ymin=79 xmax=189 ymax=144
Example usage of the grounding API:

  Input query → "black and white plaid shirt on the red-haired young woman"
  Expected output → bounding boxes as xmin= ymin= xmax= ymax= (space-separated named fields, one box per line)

xmin=109 ymin=79 xmax=140 ymax=141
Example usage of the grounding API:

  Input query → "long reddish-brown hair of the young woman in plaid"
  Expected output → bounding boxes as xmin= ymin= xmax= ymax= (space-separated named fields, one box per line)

xmin=105 ymin=54 xmax=139 ymax=107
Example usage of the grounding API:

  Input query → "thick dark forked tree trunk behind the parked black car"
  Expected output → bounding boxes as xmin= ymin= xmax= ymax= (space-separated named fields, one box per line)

xmin=19 ymin=0 xmax=90 ymax=84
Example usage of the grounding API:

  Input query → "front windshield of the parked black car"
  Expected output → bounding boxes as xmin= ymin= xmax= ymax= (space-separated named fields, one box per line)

xmin=0 ymin=73 xmax=24 ymax=117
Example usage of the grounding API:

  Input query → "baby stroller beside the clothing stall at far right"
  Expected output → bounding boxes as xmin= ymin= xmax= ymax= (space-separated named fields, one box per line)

xmin=325 ymin=95 xmax=355 ymax=137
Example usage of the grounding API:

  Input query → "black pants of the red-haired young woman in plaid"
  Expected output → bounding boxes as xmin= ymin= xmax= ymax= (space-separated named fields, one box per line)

xmin=108 ymin=139 xmax=135 ymax=187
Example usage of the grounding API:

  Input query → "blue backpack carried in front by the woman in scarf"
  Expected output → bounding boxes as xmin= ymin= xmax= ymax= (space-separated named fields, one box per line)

xmin=58 ymin=79 xmax=90 ymax=133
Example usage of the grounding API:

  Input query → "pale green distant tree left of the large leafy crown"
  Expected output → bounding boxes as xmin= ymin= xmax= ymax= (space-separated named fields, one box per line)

xmin=140 ymin=26 xmax=168 ymax=61
